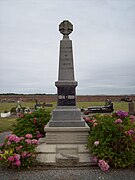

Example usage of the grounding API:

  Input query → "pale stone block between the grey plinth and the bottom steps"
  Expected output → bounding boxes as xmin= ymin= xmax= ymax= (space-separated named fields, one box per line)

xmin=44 ymin=122 xmax=89 ymax=144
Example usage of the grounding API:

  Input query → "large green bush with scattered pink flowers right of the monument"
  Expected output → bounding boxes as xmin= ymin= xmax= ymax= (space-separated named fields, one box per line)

xmin=85 ymin=111 xmax=135 ymax=171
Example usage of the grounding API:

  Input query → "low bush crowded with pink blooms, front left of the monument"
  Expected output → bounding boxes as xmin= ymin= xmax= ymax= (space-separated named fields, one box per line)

xmin=0 ymin=134 xmax=38 ymax=168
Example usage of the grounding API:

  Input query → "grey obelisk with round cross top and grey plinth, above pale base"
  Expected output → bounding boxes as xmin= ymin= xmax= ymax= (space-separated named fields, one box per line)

xmin=49 ymin=20 xmax=85 ymax=127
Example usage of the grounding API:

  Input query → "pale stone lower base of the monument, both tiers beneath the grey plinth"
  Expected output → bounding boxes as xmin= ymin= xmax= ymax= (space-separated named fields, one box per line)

xmin=37 ymin=124 xmax=95 ymax=166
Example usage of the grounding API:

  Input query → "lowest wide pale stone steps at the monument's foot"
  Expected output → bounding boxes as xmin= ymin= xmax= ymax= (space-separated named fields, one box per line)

xmin=37 ymin=143 xmax=96 ymax=166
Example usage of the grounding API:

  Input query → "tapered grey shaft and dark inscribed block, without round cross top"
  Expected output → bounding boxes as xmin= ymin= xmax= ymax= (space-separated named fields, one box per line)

xmin=55 ymin=37 xmax=77 ymax=106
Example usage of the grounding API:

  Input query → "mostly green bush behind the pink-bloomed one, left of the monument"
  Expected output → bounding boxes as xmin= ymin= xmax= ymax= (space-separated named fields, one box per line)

xmin=13 ymin=109 xmax=51 ymax=139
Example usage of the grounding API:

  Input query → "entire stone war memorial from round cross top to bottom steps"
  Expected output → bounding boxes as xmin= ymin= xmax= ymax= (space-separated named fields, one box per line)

xmin=37 ymin=20 xmax=93 ymax=165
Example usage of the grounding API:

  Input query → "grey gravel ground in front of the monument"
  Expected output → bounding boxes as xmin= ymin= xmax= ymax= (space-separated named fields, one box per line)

xmin=0 ymin=132 xmax=135 ymax=180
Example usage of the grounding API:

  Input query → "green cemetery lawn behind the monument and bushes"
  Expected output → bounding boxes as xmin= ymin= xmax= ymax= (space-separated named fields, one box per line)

xmin=0 ymin=102 xmax=128 ymax=132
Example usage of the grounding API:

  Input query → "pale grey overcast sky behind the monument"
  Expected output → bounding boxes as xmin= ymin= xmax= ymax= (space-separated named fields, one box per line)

xmin=0 ymin=0 xmax=135 ymax=95
